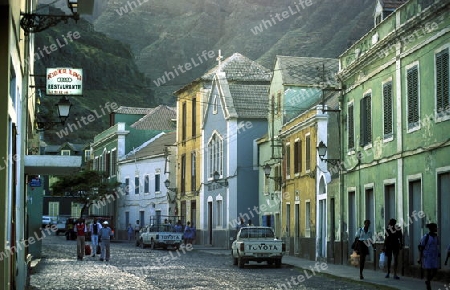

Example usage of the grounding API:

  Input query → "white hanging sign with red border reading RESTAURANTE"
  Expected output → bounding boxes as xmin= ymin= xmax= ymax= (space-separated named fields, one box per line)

xmin=46 ymin=68 xmax=83 ymax=96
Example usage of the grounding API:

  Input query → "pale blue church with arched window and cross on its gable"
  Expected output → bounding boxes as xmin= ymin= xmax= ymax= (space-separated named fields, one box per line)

xmin=197 ymin=53 xmax=271 ymax=247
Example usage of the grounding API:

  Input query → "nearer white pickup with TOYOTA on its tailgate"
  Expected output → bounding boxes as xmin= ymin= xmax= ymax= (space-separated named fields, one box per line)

xmin=231 ymin=226 xmax=286 ymax=268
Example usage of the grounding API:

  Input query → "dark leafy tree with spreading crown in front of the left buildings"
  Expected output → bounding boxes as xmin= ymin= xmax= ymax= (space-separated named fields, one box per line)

xmin=52 ymin=170 xmax=120 ymax=218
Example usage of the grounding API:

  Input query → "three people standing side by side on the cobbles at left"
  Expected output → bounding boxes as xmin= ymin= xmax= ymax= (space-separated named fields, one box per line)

xmin=74 ymin=219 xmax=114 ymax=261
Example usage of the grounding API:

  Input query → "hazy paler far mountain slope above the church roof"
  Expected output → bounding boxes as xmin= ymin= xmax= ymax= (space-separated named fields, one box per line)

xmin=94 ymin=0 xmax=375 ymax=100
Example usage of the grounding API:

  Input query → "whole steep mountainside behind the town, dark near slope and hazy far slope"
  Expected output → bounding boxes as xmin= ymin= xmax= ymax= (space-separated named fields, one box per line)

xmin=35 ymin=0 xmax=375 ymax=144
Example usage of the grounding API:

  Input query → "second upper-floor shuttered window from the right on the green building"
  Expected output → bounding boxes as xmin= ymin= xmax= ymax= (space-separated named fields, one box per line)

xmin=406 ymin=65 xmax=419 ymax=129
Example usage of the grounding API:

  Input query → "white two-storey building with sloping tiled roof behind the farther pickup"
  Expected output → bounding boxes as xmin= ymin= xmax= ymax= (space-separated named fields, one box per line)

xmin=116 ymin=132 xmax=176 ymax=238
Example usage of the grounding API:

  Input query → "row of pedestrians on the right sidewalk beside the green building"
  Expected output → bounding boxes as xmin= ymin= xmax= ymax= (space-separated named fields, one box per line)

xmin=353 ymin=219 xmax=450 ymax=290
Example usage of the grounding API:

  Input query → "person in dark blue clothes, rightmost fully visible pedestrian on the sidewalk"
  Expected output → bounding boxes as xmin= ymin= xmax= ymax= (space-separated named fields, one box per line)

xmin=419 ymin=223 xmax=439 ymax=290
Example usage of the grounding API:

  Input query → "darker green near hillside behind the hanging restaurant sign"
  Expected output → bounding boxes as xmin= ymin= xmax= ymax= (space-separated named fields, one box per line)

xmin=35 ymin=11 xmax=159 ymax=144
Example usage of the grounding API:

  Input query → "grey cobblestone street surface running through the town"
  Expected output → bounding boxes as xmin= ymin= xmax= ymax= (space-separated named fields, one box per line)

xmin=29 ymin=236 xmax=390 ymax=290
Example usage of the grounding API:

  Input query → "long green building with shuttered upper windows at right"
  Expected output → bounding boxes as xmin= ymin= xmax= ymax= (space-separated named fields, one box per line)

xmin=339 ymin=0 xmax=450 ymax=275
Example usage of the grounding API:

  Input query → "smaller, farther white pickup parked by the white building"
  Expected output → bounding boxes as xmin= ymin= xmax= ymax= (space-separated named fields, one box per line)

xmin=136 ymin=225 xmax=183 ymax=249
